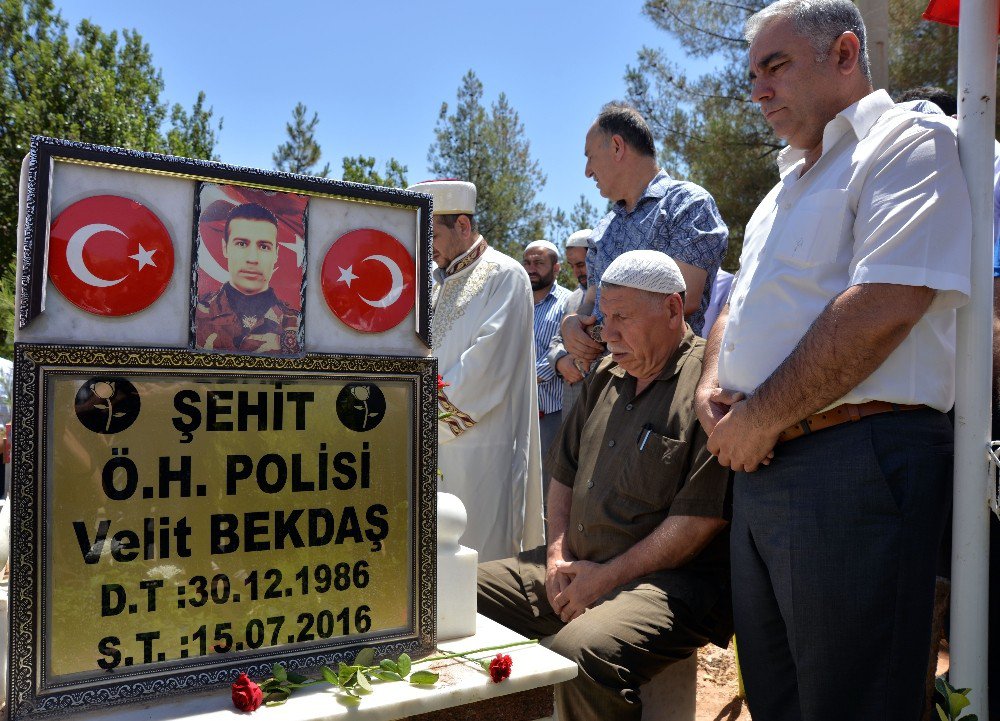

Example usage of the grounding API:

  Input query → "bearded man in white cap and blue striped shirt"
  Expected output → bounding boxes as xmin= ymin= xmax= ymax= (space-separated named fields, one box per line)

xmin=522 ymin=240 xmax=570 ymax=498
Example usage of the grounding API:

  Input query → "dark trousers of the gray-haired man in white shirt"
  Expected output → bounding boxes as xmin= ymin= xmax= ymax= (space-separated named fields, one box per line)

xmin=731 ymin=410 xmax=953 ymax=721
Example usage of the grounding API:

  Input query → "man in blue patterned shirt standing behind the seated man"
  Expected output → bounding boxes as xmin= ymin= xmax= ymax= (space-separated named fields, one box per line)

xmin=562 ymin=102 xmax=729 ymax=363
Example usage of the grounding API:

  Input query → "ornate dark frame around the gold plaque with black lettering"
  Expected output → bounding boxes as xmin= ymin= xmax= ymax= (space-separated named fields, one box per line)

xmin=7 ymin=343 xmax=437 ymax=721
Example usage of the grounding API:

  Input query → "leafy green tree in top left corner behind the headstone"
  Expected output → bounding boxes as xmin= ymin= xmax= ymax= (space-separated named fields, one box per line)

xmin=0 ymin=0 xmax=221 ymax=267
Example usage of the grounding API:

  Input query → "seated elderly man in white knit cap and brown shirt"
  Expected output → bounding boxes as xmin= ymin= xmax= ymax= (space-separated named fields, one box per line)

xmin=479 ymin=250 xmax=732 ymax=721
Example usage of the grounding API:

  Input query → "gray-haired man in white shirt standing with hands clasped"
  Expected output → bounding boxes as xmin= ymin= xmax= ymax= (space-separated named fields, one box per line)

xmin=697 ymin=0 xmax=971 ymax=721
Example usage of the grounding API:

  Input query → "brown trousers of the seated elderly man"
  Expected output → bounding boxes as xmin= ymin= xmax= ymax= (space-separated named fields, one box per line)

xmin=478 ymin=547 xmax=716 ymax=721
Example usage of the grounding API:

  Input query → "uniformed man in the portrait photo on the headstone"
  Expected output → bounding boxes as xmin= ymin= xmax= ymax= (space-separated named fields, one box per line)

xmin=194 ymin=203 xmax=300 ymax=355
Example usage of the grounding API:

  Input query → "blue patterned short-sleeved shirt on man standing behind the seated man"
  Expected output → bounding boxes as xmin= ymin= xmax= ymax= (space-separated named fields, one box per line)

xmin=587 ymin=170 xmax=729 ymax=333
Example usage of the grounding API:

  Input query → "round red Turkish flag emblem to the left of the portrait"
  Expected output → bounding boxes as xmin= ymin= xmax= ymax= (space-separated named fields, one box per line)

xmin=49 ymin=195 xmax=174 ymax=316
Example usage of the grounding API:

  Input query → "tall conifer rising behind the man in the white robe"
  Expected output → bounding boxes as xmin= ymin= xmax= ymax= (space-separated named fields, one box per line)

xmin=427 ymin=70 xmax=548 ymax=260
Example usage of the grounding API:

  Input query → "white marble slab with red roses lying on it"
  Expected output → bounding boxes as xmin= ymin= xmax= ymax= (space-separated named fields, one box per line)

xmin=68 ymin=616 xmax=577 ymax=721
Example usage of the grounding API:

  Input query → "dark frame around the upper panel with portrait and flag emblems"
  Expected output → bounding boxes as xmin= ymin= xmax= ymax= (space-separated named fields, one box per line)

xmin=17 ymin=135 xmax=432 ymax=348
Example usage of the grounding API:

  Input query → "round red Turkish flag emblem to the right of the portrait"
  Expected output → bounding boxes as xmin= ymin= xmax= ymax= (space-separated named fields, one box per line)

xmin=321 ymin=228 xmax=416 ymax=333
